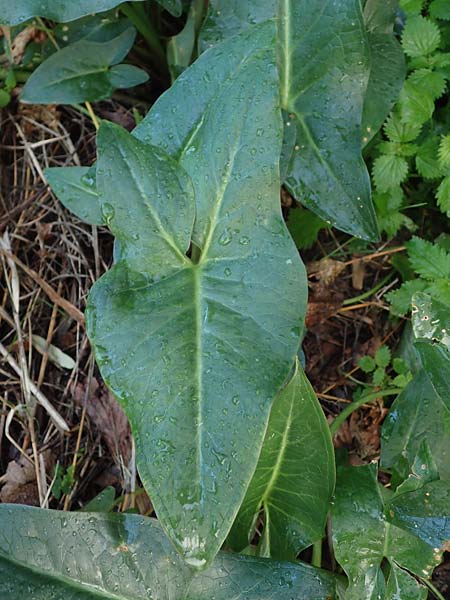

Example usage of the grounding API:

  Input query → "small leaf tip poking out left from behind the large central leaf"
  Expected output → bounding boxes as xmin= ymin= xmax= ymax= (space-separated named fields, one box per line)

xmin=45 ymin=167 xmax=105 ymax=225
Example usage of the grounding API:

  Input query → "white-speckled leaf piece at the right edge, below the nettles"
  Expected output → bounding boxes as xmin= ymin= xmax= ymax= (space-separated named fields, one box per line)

xmin=412 ymin=293 xmax=450 ymax=350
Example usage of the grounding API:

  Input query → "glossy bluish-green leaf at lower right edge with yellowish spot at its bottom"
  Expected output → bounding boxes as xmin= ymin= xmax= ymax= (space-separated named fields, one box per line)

xmin=388 ymin=481 xmax=450 ymax=562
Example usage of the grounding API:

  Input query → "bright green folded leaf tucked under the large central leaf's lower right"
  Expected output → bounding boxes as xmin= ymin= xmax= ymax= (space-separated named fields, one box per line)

xmin=228 ymin=364 xmax=335 ymax=560
